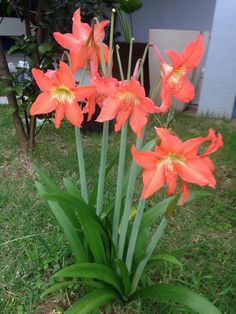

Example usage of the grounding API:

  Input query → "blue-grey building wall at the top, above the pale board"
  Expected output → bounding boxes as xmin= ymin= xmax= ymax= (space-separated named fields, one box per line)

xmin=117 ymin=0 xmax=216 ymax=42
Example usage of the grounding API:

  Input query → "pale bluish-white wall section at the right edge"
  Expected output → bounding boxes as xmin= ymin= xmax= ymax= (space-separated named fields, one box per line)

xmin=198 ymin=0 xmax=236 ymax=118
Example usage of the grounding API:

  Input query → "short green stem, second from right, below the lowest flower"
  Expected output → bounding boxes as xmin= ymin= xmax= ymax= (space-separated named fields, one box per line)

xmin=125 ymin=200 xmax=146 ymax=272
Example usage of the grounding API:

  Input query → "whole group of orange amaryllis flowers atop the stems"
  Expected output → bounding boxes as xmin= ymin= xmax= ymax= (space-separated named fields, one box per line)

xmin=31 ymin=9 xmax=222 ymax=204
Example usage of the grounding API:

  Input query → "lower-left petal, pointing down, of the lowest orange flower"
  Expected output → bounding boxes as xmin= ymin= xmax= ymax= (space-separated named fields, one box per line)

xmin=141 ymin=166 xmax=165 ymax=198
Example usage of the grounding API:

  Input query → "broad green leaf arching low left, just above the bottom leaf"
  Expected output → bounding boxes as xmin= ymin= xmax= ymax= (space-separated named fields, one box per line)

xmin=54 ymin=263 xmax=122 ymax=293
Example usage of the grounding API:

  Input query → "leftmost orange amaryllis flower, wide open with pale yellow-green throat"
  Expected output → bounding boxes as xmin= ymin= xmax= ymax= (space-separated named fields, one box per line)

xmin=30 ymin=62 xmax=94 ymax=128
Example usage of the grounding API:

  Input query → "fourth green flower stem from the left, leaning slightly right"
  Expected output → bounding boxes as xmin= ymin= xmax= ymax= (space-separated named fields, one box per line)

xmin=118 ymin=134 xmax=144 ymax=259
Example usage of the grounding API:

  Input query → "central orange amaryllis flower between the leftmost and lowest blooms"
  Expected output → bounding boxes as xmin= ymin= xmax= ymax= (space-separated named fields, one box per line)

xmin=94 ymin=78 xmax=157 ymax=137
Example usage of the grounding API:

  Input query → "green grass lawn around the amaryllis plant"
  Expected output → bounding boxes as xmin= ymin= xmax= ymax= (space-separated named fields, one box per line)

xmin=0 ymin=106 xmax=236 ymax=314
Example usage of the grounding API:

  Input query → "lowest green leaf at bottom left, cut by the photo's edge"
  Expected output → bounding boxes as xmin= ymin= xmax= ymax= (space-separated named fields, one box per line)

xmin=65 ymin=288 xmax=118 ymax=314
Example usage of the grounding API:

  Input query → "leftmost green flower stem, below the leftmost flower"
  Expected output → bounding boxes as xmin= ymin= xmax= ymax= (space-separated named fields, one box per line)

xmin=75 ymin=127 xmax=88 ymax=202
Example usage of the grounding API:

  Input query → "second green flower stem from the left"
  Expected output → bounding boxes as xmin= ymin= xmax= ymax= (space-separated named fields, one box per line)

xmin=96 ymin=121 xmax=109 ymax=215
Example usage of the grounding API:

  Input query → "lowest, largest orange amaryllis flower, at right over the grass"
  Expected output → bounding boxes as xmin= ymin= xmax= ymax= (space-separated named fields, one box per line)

xmin=131 ymin=128 xmax=223 ymax=204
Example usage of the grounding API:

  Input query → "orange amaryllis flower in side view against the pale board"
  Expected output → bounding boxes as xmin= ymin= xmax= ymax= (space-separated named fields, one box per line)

xmin=153 ymin=34 xmax=204 ymax=112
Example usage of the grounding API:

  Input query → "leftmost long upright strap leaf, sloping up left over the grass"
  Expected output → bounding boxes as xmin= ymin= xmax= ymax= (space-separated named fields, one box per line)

xmin=35 ymin=182 xmax=87 ymax=262
